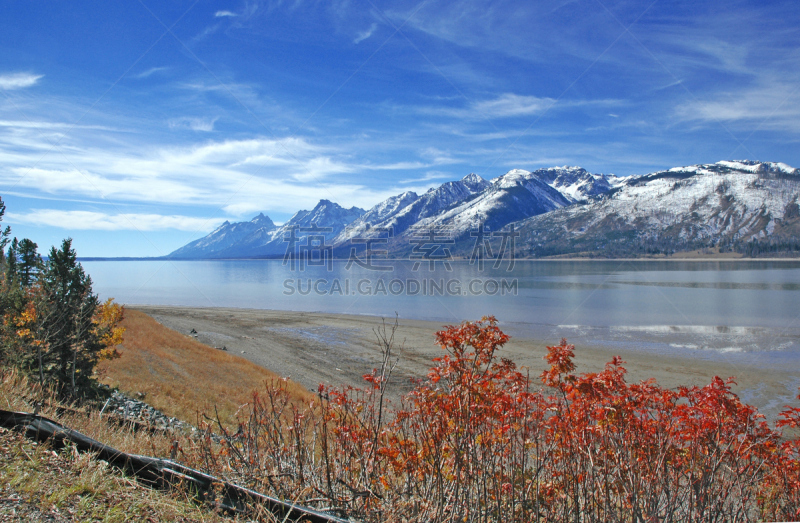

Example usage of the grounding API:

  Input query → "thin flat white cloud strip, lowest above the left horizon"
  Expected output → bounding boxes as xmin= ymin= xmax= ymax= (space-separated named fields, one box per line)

xmin=6 ymin=209 xmax=217 ymax=232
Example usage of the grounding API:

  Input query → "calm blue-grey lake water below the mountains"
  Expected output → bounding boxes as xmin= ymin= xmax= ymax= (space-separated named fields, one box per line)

xmin=82 ymin=260 xmax=800 ymax=370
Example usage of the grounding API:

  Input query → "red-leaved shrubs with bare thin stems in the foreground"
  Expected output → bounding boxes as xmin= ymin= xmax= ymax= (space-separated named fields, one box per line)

xmin=202 ymin=317 xmax=800 ymax=522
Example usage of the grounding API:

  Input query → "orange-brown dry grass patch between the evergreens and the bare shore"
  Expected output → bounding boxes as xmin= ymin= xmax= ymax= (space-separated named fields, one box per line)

xmin=98 ymin=309 xmax=314 ymax=423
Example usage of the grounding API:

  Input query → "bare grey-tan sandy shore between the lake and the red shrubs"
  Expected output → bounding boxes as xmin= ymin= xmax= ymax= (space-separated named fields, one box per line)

xmin=131 ymin=305 xmax=800 ymax=420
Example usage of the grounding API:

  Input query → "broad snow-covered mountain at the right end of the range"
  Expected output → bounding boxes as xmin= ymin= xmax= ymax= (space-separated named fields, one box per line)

xmin=517 ymin=160 xmax=800 ymax=255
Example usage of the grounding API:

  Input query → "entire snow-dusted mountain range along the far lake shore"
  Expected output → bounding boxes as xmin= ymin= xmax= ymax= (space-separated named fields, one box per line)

xmin=169 ymin=160 xmax=800 ymax=258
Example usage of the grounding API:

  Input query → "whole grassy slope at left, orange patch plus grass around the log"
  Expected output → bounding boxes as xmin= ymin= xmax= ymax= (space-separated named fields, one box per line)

xmin=0 ymin=311 xmax=322 ymax=522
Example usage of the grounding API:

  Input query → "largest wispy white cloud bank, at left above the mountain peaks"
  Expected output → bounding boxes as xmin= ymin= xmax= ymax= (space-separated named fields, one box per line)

xmin=0 ymin=136 xmax=398 ymax=216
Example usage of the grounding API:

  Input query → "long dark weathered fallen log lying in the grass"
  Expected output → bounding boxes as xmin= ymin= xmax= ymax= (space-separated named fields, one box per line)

xmin=0 ymin=409 xmax=348 ymax=523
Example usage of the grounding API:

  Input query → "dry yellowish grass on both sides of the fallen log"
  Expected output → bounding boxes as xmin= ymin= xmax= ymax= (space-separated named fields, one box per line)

xmin=0 ymin=367 xmax=304 ymax=523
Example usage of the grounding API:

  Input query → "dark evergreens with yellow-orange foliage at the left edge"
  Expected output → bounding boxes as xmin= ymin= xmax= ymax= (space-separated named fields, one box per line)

xmin=0 ymin=198 xmax=124 ymax=399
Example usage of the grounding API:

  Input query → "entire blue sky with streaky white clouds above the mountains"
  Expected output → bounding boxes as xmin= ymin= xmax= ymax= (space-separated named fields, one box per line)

xmin=0 ymin=0 xmax=800 ymax=256
